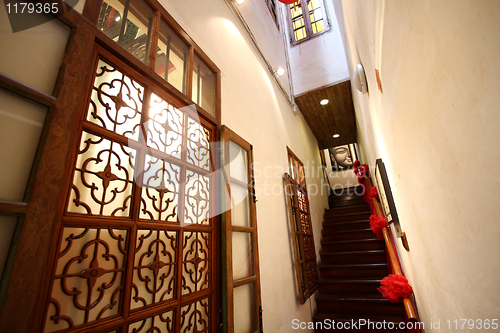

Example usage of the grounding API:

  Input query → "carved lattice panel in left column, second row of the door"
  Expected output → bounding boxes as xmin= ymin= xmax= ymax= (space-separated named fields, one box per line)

xmin=68 ymin=132 xmax=136 ymax=217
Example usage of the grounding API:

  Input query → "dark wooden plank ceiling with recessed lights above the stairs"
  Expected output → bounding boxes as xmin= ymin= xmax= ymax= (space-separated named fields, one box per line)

xmin=295 ymin=80 xmax=357 ymax=149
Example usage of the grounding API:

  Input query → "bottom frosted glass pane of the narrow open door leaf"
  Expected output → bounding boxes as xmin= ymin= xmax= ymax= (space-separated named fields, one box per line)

xmin=233 ymin=283 xmax=255 ymax=333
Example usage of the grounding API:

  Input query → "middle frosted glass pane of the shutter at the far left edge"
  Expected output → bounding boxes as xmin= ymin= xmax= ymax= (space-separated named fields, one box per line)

xmin=0 ymin=89 xmax=47 ymax=201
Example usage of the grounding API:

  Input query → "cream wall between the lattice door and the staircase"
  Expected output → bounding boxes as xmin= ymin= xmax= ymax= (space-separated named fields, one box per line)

xmin=161 ymin=0 xmax=327 ymax=333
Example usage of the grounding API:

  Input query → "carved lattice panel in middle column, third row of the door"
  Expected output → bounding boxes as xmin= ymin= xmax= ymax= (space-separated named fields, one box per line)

xmin=130 ymin=229 xmax=177 ymax=309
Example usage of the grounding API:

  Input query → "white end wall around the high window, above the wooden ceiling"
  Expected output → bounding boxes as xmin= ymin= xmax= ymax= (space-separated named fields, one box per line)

xmin=283 ymin=0 xmax=349 ymax=95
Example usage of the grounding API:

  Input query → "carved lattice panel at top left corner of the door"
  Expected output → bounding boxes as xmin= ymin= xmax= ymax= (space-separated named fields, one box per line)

xmin=87 ymin=60 xmax=144 ymax=140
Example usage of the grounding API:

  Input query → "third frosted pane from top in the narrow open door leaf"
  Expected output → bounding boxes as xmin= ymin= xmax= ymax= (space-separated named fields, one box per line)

xmin=233 ymin=231 xmax=253 ymax=281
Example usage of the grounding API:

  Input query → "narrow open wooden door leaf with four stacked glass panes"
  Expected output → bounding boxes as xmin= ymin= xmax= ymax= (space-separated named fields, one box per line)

xmin=221 ymin=126 xmax=262 ymax=333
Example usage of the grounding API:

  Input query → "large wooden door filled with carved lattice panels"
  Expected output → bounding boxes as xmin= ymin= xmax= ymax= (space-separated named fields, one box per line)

xmin=41 ymin=46 xmax=219 ymax=333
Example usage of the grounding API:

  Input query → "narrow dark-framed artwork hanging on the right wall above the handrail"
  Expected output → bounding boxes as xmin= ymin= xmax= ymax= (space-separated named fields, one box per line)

xmin=375 ymin=158 xmax=401 ymax=237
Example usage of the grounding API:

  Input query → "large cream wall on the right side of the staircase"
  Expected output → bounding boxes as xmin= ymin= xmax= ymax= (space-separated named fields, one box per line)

xmin=333 ymin=0 xmax=500 ymax=332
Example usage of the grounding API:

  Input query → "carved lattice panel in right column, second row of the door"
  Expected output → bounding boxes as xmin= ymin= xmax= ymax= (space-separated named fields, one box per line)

xmin=184 ymin=170 xmax=211 ymax=224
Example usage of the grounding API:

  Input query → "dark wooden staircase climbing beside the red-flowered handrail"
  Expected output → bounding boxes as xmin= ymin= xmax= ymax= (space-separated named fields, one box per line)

xmin=314 ymin=188 xmax=405 ymax=332
